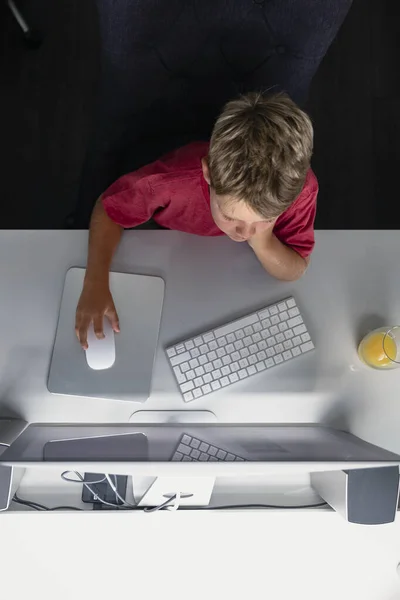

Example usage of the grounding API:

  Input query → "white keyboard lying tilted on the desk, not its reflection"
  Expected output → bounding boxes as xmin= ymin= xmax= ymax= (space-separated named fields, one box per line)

xmin=166 ymin=298 xmax=314 ymax=402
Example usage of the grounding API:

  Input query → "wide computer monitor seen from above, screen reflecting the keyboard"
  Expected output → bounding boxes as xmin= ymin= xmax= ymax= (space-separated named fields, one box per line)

xmin=0 ymin=423 xmax=400 ymax=477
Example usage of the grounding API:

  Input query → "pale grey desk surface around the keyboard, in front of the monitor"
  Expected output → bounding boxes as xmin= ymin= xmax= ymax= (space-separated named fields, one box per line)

xmin=0 ymin=231 xmax=400 ymax=452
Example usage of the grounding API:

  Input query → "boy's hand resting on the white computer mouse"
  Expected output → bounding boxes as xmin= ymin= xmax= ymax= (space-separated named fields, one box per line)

xmin=75 ymin=283 xmax=119 ymax=350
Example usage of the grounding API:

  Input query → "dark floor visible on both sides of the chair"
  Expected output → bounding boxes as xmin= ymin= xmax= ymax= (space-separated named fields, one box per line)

xmin=0 ymin=0 xmax=400 ymax=229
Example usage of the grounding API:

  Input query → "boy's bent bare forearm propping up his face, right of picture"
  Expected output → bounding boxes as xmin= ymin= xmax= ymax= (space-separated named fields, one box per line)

xmin=248 ymin=227 xmax=309 ymax=281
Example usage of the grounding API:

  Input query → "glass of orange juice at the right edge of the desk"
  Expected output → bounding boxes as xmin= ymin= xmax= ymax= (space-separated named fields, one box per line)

xmin=358 ymin=325 xmax=400 ymax=370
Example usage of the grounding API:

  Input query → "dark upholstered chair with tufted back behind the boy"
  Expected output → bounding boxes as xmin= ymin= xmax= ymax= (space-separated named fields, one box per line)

xmin=73 ymin=0 xmax=351 ymax=228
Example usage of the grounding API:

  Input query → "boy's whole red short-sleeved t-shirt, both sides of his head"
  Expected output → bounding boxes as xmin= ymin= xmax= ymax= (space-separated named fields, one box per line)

xmin=103 ymin=142 xmax=318 ymax=257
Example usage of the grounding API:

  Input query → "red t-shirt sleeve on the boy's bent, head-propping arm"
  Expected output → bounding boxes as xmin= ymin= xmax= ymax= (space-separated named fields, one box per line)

xmin=274 ymin=169 xmax=318 ymax=258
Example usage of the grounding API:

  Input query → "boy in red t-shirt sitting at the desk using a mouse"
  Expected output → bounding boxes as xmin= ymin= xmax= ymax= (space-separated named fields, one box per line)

xmin=76 ymin=93 xmax=318 ymax=349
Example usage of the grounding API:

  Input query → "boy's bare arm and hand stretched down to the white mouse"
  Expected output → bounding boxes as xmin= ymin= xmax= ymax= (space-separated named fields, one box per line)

xmin=75 ymin=196 xmax=123 ymax=349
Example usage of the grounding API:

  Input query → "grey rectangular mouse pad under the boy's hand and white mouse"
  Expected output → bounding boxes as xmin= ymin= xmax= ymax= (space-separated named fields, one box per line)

xmin=47 ymin=268 xmax=164 ymax=402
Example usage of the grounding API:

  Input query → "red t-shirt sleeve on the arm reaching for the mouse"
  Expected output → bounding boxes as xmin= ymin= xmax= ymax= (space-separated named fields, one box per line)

xmin=102 ymin=167 xmax=166 ymax=229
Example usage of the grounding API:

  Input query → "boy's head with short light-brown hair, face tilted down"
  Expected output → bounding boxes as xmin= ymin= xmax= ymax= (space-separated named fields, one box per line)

xmin=203 ymin=93 xmax=313 ymax=241
